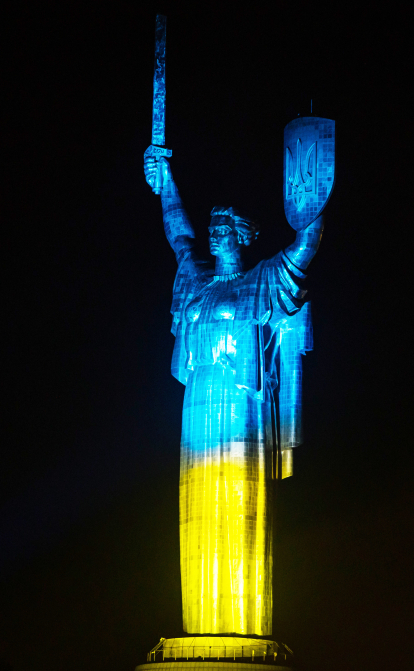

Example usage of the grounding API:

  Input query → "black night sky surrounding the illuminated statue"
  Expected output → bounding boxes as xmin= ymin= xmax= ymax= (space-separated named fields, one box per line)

xmin=0 ymin=0 xmax=414 ymax=671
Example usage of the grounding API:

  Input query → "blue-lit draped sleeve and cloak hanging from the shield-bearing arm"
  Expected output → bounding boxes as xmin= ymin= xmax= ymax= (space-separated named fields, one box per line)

xmin=235 ymin=220 xmax=322 ymax=470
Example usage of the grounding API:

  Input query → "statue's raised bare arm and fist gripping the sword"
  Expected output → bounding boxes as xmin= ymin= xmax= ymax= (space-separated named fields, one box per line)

xmin=144 ymin=156 xmax=195 ymax=255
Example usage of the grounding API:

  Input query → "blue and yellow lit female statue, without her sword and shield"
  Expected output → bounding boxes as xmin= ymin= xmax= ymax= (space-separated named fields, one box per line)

xmin=144 ymin=157 xmax=323 ymax=636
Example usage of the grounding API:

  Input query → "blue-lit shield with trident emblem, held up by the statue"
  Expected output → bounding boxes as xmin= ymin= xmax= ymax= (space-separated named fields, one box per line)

xmin=283 ymin=117 xmax=335 ymax=231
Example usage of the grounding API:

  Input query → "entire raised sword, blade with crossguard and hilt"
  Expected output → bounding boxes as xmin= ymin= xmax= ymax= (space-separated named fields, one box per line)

xmin=145 ymin=14 xmax=172 ymax=195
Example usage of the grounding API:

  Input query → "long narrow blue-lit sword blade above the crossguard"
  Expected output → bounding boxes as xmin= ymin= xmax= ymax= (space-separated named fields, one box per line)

xmin=152 ymin=14 xmax=167 ymax=146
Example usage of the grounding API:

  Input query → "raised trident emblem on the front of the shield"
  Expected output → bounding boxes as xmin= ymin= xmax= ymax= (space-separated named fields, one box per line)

xmin=286 ymin=138 xmax=317 ymax=212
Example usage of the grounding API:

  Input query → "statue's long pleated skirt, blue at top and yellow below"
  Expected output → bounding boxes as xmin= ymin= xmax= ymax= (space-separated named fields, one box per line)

xmin=180 ymin=363 xmax=273 ymax=636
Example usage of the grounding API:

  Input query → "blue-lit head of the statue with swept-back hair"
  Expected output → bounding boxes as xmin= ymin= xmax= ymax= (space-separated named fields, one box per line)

xmin=208 ymin=207 xmax=259 ymax=257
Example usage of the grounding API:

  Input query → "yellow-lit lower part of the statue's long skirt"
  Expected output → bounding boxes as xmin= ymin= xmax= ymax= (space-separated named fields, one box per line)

xmin=180 ymin=445 xmax=272 ymax=635
